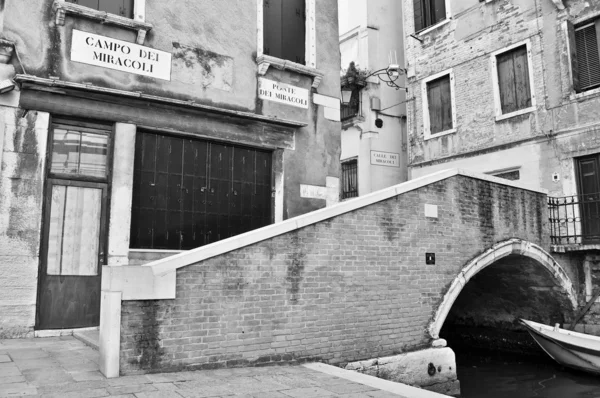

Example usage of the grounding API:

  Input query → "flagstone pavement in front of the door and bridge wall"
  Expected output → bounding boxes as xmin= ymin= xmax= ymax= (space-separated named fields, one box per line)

xmin=0 ymin=336 xmax=442 ymax=398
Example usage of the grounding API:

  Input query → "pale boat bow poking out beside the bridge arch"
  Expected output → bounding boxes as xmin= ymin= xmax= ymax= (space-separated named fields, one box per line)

xmin=521 ymin=319 xmax=600 ymax=374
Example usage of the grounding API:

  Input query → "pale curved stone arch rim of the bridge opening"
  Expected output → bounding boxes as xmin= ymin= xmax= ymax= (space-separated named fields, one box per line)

xmin=428 ymin=239 xmax=577 ymax=339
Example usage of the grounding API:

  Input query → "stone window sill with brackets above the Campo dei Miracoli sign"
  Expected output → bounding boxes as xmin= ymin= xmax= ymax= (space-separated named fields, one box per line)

xmin=52 ymin=0 xmax=152 ymax=44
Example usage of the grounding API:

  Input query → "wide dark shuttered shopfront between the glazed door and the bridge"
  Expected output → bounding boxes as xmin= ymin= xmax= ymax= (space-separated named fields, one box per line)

xmin=130 ymin=132 xmax=271 ymax=250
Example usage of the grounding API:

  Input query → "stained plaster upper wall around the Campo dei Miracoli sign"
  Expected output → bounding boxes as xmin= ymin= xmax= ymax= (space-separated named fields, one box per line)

xmin=3 ymin=0 xmax=340 ymax=218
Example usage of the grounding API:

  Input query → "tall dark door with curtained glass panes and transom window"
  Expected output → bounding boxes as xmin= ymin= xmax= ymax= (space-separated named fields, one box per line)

xmin=36 ymin=119 xmax=111 ymax=329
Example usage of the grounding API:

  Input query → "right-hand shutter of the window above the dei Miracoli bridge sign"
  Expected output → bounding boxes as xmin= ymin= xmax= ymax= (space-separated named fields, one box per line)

xmin=281 ymin=0 xmax=306 ymax=64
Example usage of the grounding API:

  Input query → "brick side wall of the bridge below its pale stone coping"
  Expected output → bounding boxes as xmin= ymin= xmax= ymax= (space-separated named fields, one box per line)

xmin=120 ymin=176 xmax=548 ymax=374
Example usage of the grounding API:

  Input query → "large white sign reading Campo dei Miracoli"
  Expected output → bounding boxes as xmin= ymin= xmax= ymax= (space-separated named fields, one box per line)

xmin=71 ymin=29 xmax=171 ymax=80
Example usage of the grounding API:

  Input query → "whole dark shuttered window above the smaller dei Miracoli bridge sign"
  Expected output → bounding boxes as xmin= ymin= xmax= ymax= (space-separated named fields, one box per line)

xmin=263 ymin=0 xmax=306 ymax=64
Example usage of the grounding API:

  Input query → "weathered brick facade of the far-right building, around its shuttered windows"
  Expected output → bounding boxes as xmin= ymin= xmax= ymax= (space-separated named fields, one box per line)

xmin=404 ymin=0 xmax=600 ymax=195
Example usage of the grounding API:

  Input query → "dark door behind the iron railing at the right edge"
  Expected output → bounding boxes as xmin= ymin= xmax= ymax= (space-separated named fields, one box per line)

xmin=577 ymin=155 xmax=600 ymax=243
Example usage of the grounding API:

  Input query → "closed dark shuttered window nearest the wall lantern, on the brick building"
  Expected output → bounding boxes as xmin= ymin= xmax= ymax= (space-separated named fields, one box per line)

xmin=427 ymin=75 xmax=453 ymax=134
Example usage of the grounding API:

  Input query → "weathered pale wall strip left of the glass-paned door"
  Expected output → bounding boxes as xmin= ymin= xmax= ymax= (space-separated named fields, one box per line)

xmin=0 ymin=107 xmax=49 ymax=339
